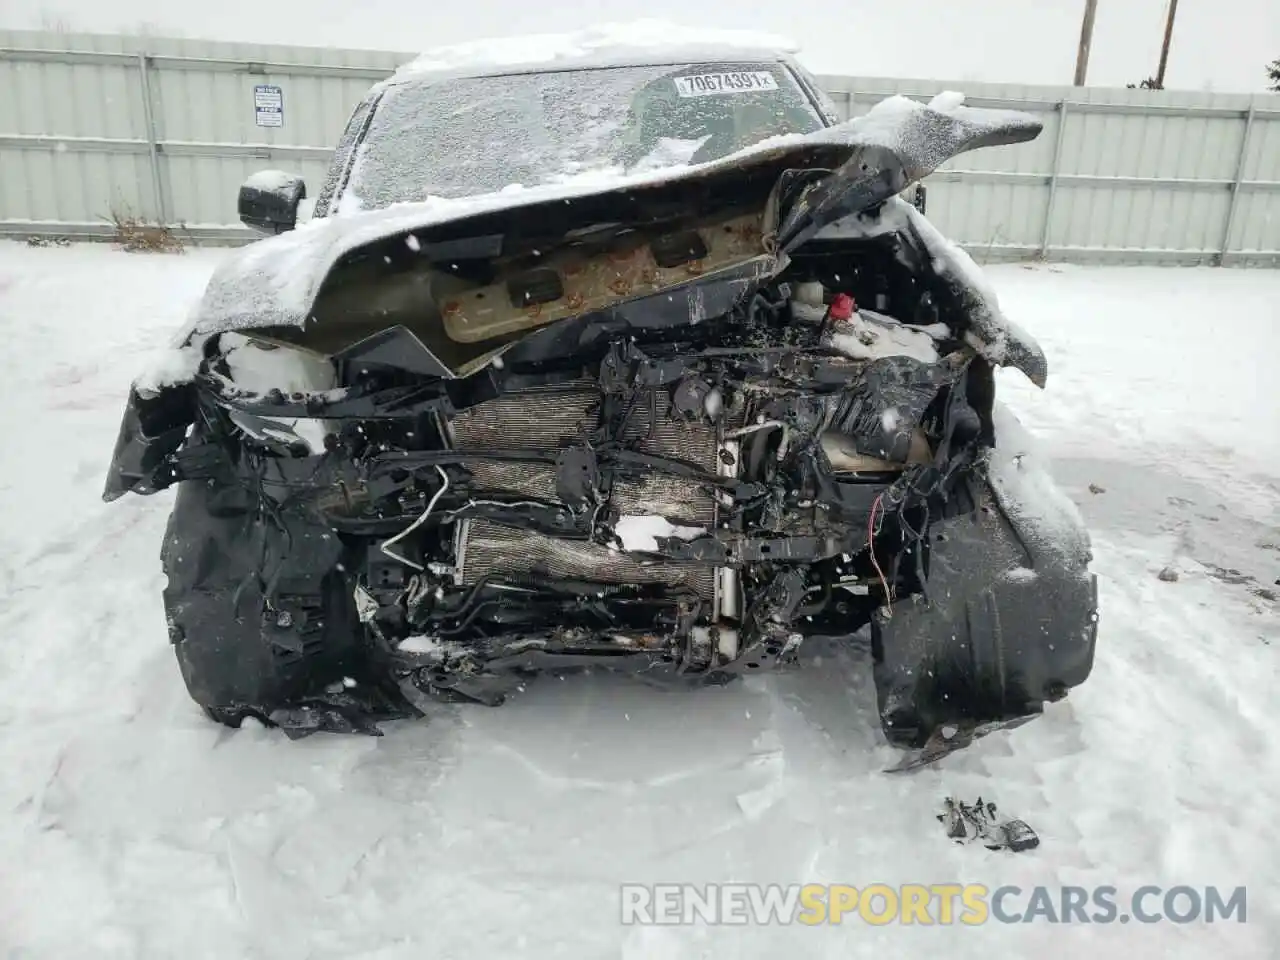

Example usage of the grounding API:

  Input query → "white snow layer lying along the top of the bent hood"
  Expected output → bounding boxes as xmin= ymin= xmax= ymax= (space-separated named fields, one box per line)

xmin=186 ymin=90 xmax=1029 ymax=337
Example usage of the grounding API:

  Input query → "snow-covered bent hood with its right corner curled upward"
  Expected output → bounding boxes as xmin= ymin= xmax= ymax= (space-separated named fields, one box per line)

xmin=183 ymin=93 xmax=1042 ymax=340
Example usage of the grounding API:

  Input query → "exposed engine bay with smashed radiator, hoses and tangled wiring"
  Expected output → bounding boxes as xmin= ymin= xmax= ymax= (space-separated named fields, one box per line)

xmin=175 ymin=220 xmax=991 ymax=703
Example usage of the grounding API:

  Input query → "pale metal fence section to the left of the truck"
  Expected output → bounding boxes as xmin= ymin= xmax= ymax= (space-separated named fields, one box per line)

xmin=0 ymin=31 xmax=408 ymax=235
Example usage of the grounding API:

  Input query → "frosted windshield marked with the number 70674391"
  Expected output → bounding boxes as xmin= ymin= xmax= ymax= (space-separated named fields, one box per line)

xmin=337 ymin=63 xmax=823 ymax=212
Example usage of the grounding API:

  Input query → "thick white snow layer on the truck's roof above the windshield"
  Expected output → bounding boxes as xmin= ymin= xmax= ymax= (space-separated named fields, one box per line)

xmin=392 ymin=19 xmax=799 ymax=82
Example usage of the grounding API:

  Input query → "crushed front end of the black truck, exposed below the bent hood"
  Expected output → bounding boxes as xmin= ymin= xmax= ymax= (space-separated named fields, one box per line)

xmin=109 ymin=99 xmax=1097 ymax=751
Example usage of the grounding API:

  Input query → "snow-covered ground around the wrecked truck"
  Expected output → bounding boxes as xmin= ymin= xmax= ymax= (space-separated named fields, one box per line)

xmin=0 ymin=243 xmax=1280 ymax=960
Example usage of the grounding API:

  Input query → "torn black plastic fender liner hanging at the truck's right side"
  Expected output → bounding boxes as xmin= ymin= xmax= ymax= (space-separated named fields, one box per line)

xmin=872 ymin=485 xmax=1097 ymax=759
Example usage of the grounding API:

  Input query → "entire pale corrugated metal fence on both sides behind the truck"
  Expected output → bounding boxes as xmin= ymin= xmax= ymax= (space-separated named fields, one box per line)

xmin=0 ymin=31 xmax=1280 ymax=266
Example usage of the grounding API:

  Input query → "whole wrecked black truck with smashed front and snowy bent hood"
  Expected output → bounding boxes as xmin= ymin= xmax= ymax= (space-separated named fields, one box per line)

xmin=105 ymin=49 xmax=1097 ymax=758
